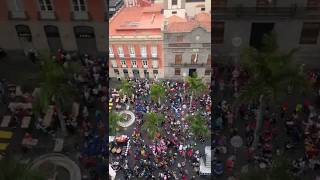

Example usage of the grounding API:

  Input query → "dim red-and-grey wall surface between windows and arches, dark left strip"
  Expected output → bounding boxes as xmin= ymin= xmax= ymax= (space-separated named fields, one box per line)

xmin=0 ymin=0 xmax=107 ymax=53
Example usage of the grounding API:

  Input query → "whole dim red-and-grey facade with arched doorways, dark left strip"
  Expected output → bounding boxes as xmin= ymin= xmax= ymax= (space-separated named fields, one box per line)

xmin=0 ymin=0 xmax=108 ymax=54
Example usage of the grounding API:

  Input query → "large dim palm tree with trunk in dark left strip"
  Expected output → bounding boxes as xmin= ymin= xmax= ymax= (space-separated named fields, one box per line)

xmin=33 ymin=53 xmax=77 ymax=136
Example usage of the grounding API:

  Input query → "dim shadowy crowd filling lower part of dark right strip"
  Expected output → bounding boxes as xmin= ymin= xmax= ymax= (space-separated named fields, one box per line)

xmin=213 ymin=63 xmax=320 ymax=179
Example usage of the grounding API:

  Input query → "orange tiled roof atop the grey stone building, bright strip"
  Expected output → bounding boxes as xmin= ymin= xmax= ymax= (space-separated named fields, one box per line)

xmin=167 ymin=13 xmax=211 ymax=33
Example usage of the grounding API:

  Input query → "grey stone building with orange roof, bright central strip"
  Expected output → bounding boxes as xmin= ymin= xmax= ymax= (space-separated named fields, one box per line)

xmin=163 ymin=13 xmax=212 ymax=82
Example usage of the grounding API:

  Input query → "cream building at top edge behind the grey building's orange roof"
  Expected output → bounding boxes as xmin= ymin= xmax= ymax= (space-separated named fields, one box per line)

xmin=164 ymin=0 xmax=211 ymax=18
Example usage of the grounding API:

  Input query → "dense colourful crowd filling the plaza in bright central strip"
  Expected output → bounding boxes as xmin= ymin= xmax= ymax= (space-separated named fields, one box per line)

xmin=111 ymin=79 xmax=211 ymax=179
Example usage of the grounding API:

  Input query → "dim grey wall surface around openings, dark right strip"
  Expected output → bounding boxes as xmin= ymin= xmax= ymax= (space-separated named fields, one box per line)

xmin=212 ymin=0 xmax=320 ymax=67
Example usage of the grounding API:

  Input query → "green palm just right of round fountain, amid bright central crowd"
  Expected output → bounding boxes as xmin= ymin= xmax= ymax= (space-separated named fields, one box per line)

xmin=142 ymin=112 xmax=164 ymax=139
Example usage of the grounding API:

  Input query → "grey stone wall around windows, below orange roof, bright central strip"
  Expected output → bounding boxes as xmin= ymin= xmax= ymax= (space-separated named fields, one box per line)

xmin=163 ymin=27 xmax=211 ymax=81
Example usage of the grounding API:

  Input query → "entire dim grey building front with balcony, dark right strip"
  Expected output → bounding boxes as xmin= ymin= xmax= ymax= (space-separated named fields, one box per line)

xmin=212 ymin=0 xmax=320 ymax=67
